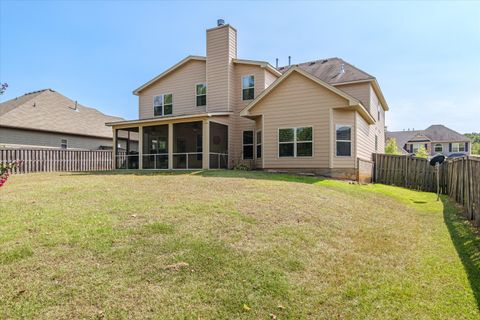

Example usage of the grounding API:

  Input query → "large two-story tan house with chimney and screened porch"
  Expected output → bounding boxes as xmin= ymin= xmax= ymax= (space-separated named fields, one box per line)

xmin=109 ymin=20 xmax=388 ymax=178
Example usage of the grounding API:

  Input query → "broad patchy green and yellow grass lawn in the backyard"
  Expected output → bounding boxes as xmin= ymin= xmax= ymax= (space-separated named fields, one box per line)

xmin=0 ymin=171 xmax=480 ymax=319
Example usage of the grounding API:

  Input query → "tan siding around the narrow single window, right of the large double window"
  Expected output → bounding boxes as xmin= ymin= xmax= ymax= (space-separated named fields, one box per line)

xmin=332 ymin=109 xmax=361 ymax=168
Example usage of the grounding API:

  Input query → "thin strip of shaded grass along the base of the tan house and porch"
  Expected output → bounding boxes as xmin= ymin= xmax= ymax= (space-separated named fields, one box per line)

xmin=65 ymin=170 xmax=327 ymax=184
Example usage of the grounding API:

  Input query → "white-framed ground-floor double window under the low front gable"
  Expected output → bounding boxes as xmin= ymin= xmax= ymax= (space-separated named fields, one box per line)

xmin=278 ymin=127 xmax=313 ymax=157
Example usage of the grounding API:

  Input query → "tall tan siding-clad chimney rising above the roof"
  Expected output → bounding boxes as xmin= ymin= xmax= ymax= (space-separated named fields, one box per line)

xmin=206 ymin=25 xmax=237 ymax=112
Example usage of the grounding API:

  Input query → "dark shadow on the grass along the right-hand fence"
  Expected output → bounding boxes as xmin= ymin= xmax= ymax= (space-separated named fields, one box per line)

xmin=441 ymin=196 xmax=480 ymax=311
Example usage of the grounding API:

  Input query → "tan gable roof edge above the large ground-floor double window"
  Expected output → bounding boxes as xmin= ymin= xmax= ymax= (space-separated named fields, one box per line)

xmin=240 ymin=66 xmax=375 ymax=123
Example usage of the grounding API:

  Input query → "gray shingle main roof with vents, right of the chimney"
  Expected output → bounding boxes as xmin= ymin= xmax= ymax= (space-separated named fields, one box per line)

xmin=278 ymin=58 xmax=375 ymax=84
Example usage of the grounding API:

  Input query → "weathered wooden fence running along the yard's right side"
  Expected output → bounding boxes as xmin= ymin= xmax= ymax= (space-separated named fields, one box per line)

xmin=373 ymin=154 xmax=480 ymax=226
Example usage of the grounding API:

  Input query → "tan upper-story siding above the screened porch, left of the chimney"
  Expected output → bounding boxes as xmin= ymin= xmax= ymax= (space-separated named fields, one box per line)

xmin=138 ymin=60 xmax=206 ymax=119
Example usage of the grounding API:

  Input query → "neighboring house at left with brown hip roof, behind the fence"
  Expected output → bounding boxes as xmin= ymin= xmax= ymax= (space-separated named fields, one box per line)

xmin=0 ymin=89 xmax=122 ymax=150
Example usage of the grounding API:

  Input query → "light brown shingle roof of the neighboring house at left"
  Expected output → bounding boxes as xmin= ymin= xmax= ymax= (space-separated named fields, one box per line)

xmin=0 ymin=89 xmax=123 ymax=138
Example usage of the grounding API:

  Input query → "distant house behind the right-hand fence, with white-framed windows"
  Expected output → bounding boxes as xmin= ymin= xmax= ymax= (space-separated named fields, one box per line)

xmin=386 ymin=124 xmax=471 ymax=156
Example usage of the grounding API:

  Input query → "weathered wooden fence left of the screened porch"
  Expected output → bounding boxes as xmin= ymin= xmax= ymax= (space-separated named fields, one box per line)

xmin=0 ymin=149 xmax=112 ymax=173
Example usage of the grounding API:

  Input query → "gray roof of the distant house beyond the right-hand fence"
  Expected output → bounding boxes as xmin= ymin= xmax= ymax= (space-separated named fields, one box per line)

xmin=386 ymin=124 xmax=470 ymax=148
